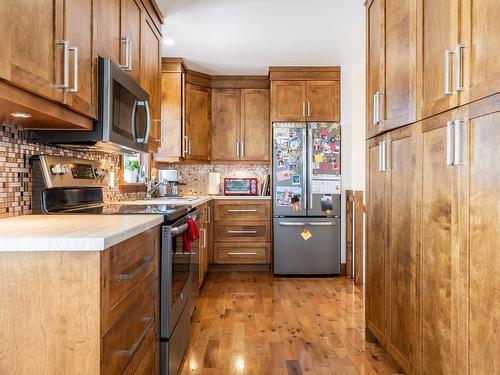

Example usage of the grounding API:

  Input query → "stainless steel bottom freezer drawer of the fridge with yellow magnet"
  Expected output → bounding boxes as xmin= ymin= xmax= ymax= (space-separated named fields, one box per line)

xmin=273 ymin=217 xmax=340 ymax=275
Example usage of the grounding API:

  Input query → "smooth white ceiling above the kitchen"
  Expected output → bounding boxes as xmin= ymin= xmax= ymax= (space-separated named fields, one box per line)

xmin=157 ymin=0 xmax=365 ymax=74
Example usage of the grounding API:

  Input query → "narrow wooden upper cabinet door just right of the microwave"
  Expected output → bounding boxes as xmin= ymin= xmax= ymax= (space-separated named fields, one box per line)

xmin=141 ymin=12 xmax=162 ymax=150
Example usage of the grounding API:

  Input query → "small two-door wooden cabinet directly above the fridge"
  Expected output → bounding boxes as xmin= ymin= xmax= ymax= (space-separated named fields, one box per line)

xmin=271 ymin=80 xmax=340 ymax=121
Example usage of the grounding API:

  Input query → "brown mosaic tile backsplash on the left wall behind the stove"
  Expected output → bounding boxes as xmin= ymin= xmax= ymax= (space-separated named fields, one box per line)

xmin=0 ymin=124 xmax=144 ymax=218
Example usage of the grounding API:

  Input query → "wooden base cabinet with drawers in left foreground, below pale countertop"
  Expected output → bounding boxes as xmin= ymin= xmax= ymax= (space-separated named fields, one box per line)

xmin=0 ymin=226 xmax=161 ymax=374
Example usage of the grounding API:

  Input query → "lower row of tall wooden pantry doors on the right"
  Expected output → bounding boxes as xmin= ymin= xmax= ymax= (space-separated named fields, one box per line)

xmin=366 ymin=95 xmax=500 ymax=374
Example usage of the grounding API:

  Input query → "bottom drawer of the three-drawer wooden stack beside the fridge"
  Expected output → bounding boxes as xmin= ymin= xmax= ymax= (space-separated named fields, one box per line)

xmin=214 ymin=243 xmax=271 ymax=264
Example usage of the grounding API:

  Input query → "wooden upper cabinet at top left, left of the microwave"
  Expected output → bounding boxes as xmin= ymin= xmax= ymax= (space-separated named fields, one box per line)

xmin=0 ymin=0 xmax=97 ymax=129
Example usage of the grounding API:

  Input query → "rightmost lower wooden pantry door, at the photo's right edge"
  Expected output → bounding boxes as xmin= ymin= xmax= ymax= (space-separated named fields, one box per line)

xmin=459 ymin=95 xmax=500 ymax=375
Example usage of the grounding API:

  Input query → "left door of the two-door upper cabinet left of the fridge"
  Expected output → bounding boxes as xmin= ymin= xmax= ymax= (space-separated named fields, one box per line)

xmin=212 ymin=89 xmax=241 ymax=161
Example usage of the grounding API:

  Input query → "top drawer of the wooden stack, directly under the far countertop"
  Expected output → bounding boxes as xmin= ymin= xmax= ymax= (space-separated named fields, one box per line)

xmin=214 ymin=200 xmax=271 ymax=222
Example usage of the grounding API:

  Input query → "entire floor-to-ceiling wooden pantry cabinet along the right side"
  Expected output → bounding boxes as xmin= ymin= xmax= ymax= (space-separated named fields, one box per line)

xmin=366 ymin=0 xmax=500 ymax=375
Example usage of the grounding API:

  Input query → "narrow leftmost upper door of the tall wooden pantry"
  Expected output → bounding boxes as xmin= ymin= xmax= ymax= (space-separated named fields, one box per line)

xmin=366 ymin=0 xmax=384 ymax=138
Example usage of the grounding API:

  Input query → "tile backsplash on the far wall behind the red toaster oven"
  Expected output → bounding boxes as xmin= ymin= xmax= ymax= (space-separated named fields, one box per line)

xmin=158 ymin=163 xmax=269 ymax=195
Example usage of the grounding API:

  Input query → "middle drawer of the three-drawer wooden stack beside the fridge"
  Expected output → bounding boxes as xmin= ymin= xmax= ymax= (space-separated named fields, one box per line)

xmin=214 ymin=221 xmax=271 ymax=242
